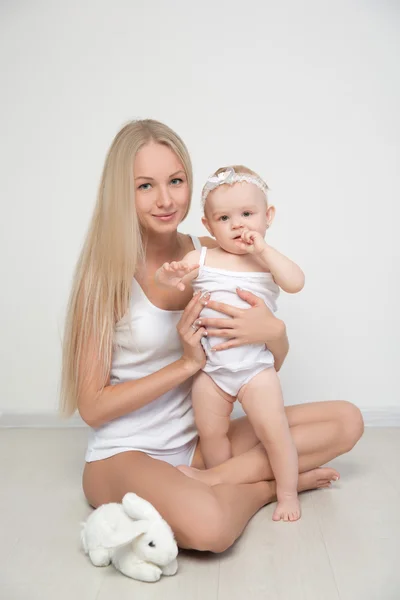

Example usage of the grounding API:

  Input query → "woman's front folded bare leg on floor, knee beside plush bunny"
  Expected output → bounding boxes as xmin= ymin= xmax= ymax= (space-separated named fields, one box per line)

xmin=83 ymin=452 xmax=340 ymax=552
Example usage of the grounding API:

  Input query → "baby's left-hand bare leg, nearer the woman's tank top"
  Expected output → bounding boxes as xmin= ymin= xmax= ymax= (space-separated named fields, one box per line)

xmin=192 ymin=371 xmax=235 ymax=469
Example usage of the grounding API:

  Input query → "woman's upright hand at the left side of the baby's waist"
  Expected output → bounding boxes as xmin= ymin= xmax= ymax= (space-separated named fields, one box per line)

xmin=176 ymin=292 xmax=210 ymax=374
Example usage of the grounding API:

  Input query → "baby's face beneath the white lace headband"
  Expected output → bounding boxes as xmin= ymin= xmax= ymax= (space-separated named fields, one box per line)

xmin=203 ymin=182 xmax=272 ymax=254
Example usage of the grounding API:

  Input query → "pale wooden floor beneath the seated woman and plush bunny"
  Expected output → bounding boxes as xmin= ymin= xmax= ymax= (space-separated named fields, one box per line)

xmin=0 ymin=428 xmax=400 ymax=600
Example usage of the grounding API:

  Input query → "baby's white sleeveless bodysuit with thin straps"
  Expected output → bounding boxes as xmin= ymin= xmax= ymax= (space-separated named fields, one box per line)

xmin=192 ymin=248 xmax=279 ymax=396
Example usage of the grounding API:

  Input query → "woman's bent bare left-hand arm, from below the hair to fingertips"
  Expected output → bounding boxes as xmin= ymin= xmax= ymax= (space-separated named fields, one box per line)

xmin=78 ymin=294 xmax=206 ymax=427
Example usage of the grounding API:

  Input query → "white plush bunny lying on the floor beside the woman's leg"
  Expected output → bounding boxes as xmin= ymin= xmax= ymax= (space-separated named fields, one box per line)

xmin=81 ymin=493 xmax=178 ymax=581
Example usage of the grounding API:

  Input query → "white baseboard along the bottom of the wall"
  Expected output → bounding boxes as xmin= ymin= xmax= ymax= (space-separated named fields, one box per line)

xmin=0 ymin=406 xmax=400 ymax=429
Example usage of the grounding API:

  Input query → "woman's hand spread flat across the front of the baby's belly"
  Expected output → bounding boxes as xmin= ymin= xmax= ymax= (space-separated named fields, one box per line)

xmin=199 ymin=289 xmax=286 ymax=350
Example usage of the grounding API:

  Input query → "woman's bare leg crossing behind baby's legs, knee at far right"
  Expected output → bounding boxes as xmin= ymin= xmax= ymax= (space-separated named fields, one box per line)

xmin=180 ymin=401 xmax=364 ymax=485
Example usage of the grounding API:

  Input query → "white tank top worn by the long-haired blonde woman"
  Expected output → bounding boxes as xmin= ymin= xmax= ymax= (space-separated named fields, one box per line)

xmin=86 ymin=236 xmax=201 ymax=462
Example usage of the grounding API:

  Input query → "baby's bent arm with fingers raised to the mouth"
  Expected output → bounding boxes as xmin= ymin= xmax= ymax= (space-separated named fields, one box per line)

xmin=239 ymin=229 xmax=304 ymax=294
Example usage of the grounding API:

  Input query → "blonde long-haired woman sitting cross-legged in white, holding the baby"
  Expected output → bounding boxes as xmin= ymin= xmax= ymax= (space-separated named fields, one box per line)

xmin=62 ymin=120 xmax=363 ymax=552
